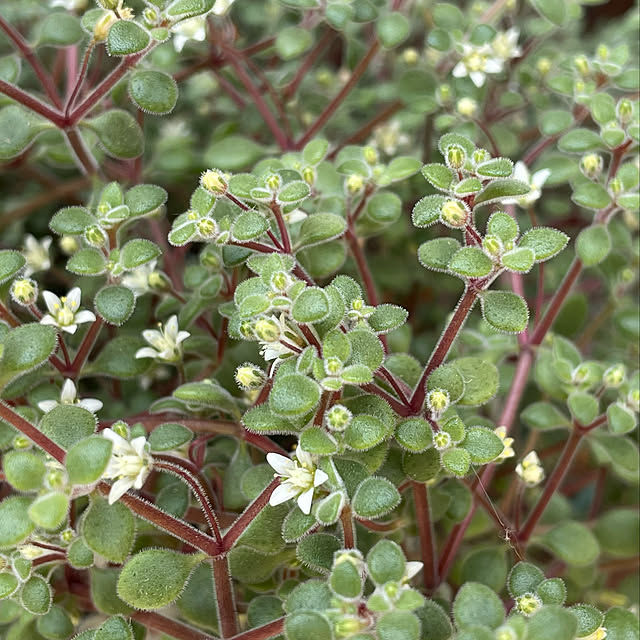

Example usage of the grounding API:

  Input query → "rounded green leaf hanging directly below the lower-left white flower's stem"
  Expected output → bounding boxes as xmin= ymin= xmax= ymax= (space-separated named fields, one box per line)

xmin=82 ymin=496 xmax=135 ymax=564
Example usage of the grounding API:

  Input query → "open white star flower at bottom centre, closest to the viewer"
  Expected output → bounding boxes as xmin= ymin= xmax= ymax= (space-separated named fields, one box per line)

xmin=267 ymin=447 xmax=329 ymax=515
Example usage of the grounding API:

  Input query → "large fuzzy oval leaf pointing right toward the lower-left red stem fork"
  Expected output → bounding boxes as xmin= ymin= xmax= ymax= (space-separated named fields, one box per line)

xmin=118 ymin=549 xmax=204 ymax=611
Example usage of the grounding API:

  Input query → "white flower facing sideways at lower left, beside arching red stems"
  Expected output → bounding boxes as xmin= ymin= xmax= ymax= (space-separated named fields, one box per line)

xmin=102 ymin=429 xmax=153 ymax=504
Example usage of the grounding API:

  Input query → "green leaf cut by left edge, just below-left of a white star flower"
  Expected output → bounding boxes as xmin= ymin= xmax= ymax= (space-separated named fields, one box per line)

xmin=0 ymin=323 xmax=57 ymax=387
